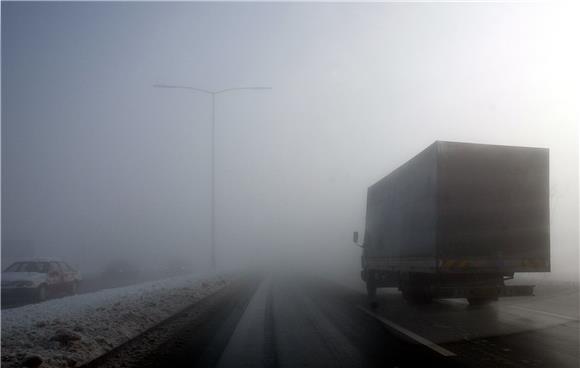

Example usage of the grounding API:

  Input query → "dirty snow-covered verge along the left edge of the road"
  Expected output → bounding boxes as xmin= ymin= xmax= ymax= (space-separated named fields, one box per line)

xmin=1 ymin=275 xmax=229 ymax=368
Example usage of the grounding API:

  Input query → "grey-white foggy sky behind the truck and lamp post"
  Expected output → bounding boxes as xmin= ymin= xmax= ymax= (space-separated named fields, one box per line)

xmin=2 ymin=2 xmax=580 ymax=279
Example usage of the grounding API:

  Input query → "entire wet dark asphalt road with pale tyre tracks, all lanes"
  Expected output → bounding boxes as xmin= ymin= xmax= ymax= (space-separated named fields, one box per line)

xmin=81 ymin=275 xmax=580 ymax=368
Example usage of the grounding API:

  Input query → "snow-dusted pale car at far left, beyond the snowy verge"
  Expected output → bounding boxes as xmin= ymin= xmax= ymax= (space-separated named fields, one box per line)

xmin=2 ymin=259 xmax=81 ymax=301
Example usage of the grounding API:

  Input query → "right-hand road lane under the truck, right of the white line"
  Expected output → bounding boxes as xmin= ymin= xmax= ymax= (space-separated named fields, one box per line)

xmin=360 ymin=278 xmax=580 ymax=368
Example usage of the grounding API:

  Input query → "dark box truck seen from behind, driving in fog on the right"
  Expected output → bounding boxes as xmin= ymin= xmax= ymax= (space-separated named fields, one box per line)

xmin=353 ymin=141 xmax=550 ymax=304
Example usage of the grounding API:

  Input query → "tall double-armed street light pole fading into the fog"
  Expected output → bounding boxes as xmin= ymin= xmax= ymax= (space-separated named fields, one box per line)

xmin=153 ymin=84 xmax=272 ymax=271
